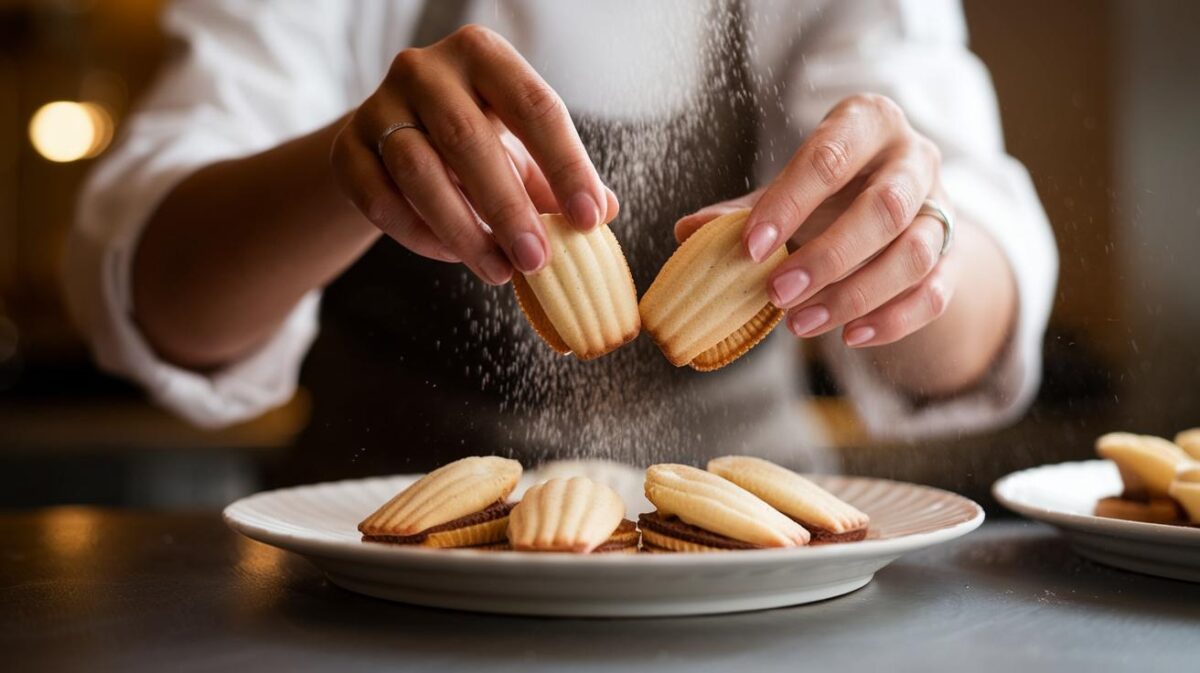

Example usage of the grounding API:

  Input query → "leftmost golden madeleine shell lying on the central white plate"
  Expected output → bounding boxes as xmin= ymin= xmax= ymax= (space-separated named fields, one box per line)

xmin=359 ymin=456 xmax=521 ymax=536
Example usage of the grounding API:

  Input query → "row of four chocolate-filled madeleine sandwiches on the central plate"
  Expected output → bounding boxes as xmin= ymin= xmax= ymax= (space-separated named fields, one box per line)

xmin=359 ymin=456 xmax=870 ymax=554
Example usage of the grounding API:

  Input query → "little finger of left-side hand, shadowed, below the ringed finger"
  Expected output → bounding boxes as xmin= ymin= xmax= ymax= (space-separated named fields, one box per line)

xmin=332 ymin=123 xmax=460 ymax=262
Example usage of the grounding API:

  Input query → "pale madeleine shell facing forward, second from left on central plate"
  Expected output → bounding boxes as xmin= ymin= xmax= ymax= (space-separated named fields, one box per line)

xmin=509 ymin=476 xmax=625 ymax=554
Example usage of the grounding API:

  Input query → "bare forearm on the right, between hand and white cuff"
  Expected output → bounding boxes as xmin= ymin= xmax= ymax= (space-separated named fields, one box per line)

xmin=869 ymin=222 xmax=1018 ymax=397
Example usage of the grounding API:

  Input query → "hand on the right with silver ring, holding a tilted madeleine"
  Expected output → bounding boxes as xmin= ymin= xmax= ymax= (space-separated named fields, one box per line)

xmin=676 ymin=95 xmax=955 ymax=347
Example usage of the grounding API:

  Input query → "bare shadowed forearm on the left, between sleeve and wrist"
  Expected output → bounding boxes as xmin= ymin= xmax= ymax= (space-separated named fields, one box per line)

xmin=132 ymin=113 xmax=379 ymax=369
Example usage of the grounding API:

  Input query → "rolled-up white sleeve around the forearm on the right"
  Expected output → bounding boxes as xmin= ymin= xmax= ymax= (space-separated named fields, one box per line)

xmin=756 ymin=0 xmax=1058 ymax=439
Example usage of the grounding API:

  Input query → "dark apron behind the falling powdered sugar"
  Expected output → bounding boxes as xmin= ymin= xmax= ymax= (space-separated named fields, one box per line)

xmin=272 ymin=0 xmax=816 ymax=483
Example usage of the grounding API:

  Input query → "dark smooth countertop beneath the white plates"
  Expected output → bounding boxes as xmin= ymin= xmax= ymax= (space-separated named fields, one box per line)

xmin=0 ymin=507 xmax=1200 ymax=673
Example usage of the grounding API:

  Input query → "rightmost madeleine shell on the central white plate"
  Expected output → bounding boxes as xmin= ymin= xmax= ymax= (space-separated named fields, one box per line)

xmin=708 ymin=456 xmax=871 ymax=533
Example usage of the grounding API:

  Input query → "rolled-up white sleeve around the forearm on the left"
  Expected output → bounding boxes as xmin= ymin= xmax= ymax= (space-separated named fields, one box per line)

xmin=65 ymin=0 xmax=349 ymax=427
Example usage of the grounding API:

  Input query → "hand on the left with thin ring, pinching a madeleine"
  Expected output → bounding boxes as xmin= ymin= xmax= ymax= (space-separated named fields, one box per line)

xmin=330 ymin=25 xmax=618 ymax=284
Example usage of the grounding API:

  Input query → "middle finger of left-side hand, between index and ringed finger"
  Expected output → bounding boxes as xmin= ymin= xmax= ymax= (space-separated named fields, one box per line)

xmin=403 ymin=70 xmax=550 ymax=274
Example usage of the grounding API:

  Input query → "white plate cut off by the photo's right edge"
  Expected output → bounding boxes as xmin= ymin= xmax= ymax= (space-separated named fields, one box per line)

xmin=991 ymin=461 xmax=1200 ymax=582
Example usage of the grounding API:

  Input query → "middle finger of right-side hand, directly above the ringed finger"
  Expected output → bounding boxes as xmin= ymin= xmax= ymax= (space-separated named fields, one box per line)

xmin=769 ymin=142 xmax=937 ymax=308
